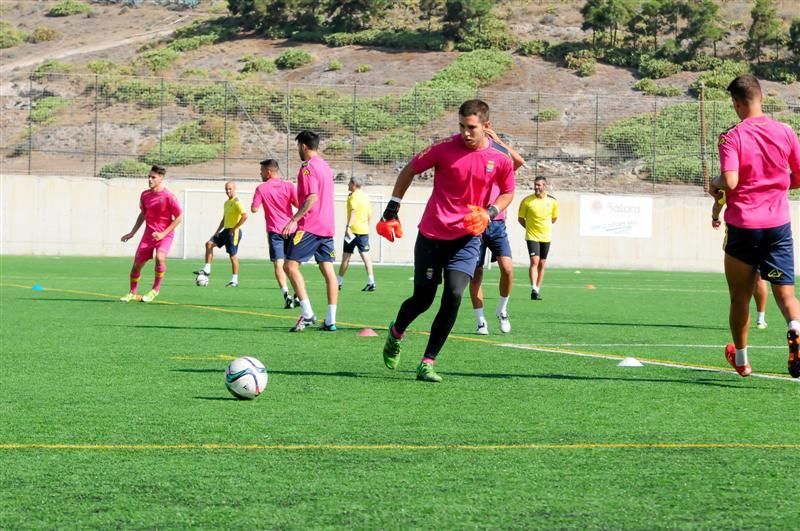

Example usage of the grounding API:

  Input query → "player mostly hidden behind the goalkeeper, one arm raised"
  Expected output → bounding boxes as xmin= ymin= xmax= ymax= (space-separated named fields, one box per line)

xmin=469 ymin=128 xmax=525 ymax=336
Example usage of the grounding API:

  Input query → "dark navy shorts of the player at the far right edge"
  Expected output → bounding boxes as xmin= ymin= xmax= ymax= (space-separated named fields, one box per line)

xmin=723 ymin=223 xmax=794 ymax=285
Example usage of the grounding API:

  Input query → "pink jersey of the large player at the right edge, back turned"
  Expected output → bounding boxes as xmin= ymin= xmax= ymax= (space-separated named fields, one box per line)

xmin=719 ymin=116 xmax=800 ymax=229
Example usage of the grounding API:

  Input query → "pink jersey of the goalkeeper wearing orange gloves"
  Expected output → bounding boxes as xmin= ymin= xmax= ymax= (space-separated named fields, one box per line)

xmin=411 ymin=134 xmax=514 ymax=240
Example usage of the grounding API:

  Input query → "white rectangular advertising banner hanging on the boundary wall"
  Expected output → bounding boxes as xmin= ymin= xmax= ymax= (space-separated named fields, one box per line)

xmin=581 ymin=195 xmax=653 ymax=238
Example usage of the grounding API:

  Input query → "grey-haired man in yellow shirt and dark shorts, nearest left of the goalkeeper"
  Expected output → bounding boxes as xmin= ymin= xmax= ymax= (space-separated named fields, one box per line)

xmin=336 ymin=175 xmax=375 ymax=291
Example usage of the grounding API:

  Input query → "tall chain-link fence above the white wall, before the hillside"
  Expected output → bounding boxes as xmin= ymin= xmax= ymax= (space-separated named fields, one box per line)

xmin=0 ymin=74 xmax=800 ymax=193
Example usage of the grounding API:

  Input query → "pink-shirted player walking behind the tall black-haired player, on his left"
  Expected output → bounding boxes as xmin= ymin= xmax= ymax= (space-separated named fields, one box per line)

xmin=250 ymin=159 xmax=297 ymax=309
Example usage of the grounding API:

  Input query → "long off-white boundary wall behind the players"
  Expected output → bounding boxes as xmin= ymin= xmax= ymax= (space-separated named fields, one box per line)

xmin=0 ymin=175 xmax=800 ymax=271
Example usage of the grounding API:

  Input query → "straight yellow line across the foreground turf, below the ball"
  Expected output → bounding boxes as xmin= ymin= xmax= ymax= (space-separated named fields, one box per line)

xmin=0 ymin=443 xmax=800 ymax=451
